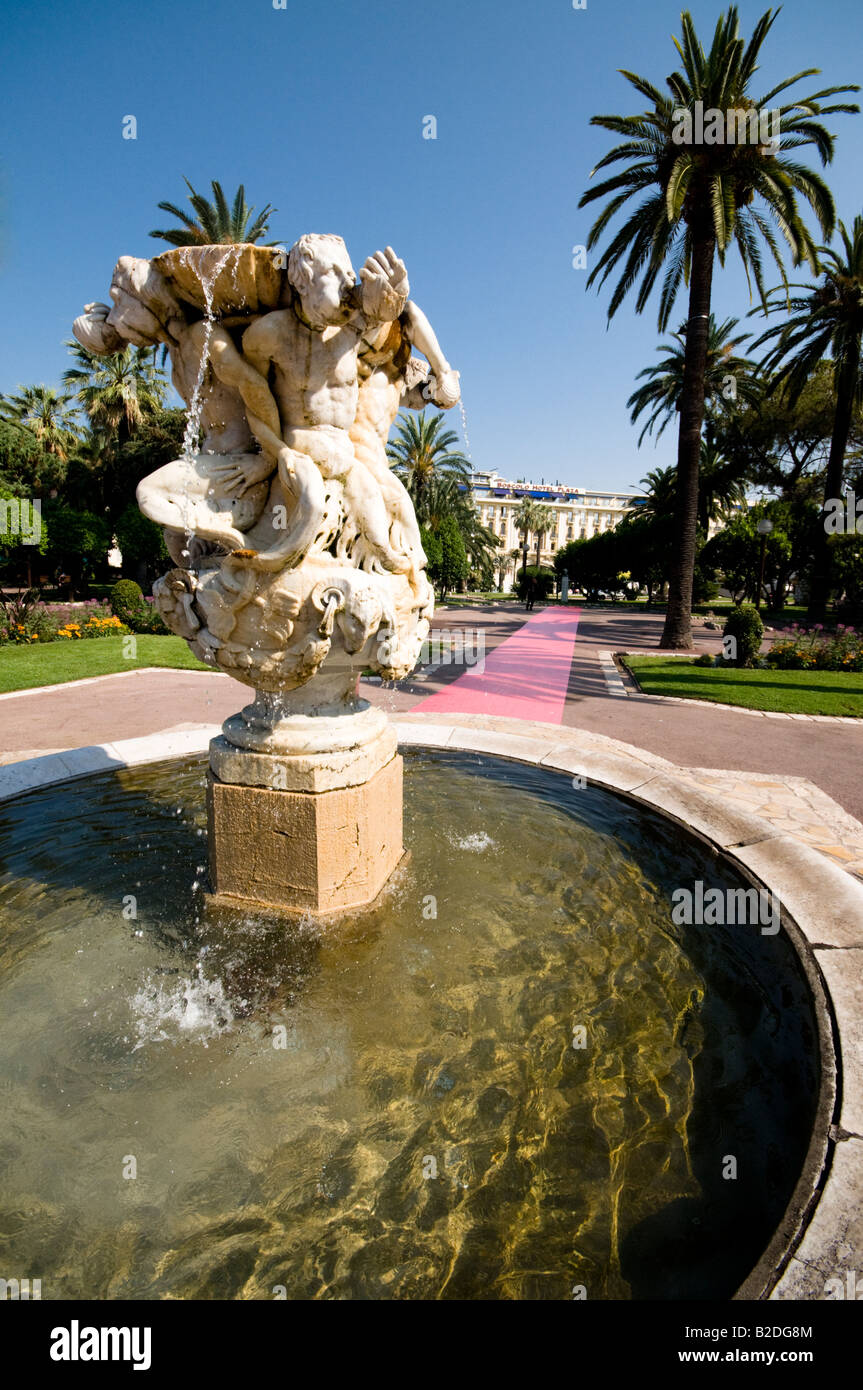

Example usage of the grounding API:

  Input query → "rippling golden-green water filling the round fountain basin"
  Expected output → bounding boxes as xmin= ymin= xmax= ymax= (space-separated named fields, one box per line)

xmin=0 ymin=730 xmax=831 ymax=1298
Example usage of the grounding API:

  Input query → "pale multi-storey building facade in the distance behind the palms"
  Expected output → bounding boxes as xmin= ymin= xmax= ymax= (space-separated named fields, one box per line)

xmin=471 ymin=470 xmax=643 ymax=591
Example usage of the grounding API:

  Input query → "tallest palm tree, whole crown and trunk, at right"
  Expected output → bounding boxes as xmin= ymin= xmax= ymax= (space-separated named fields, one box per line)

xmin=580 ymin=6 xmax=859 ymax=651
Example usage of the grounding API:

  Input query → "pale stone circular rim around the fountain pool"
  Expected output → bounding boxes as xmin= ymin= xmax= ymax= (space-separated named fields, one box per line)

xmin=0 ymin=714 xmax=863 ymax=1300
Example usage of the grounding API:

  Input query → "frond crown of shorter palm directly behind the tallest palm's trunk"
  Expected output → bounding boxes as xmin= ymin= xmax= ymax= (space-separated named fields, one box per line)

xmin=627 ymin=314 xmax=760 ymax=449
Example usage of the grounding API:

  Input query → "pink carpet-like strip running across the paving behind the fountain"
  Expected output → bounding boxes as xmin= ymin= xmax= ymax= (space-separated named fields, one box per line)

xmin=413 ymin=607 xmax=581 ymax=724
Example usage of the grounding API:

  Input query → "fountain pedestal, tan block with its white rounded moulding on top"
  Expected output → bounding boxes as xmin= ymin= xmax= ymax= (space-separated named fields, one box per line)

xmin=207 ymin=684 xmax=404 ymax=913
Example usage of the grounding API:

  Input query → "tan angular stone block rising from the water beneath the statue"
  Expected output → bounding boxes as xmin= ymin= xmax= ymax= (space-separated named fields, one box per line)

xmin=207 ymin=756 xmax=404 ymax=915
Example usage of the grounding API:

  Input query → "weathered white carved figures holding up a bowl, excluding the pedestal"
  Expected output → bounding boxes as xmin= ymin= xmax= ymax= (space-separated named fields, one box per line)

xmin=75 ymin=235 xmax=459 ymax=717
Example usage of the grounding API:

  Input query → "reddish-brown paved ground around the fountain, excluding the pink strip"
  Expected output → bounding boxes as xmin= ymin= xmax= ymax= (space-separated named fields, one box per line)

xmin=0 ymin=603 xmax=863 ymax=877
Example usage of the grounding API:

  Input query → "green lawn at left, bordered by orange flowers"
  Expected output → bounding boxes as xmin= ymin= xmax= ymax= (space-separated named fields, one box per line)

xmin=0 ymin=637 xmax=210 ymax=692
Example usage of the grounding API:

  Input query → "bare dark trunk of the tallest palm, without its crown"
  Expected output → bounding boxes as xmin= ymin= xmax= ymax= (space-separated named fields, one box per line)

xmin=660 ymin=220 xmax=716 ymax=652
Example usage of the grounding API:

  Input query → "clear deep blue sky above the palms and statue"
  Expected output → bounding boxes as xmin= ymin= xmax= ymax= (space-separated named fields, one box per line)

xmin=0 ymin=0 xmax=863 ymax=488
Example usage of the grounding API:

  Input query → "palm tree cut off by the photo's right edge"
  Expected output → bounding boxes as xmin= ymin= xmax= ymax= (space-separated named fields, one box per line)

xmin=753 ymin=214 xmax=863 ymax=623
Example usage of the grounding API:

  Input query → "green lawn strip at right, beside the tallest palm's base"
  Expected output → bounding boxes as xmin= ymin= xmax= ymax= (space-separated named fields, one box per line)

xmin=625 ymin=656 xmax=863 ymax=719
